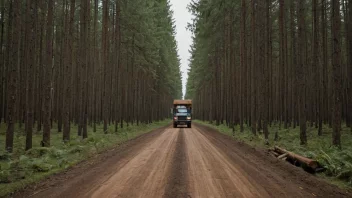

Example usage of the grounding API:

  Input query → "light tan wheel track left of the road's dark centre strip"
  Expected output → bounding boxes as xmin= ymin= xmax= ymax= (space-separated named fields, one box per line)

xmin=89 ymin=129 xmax=179 ymax=198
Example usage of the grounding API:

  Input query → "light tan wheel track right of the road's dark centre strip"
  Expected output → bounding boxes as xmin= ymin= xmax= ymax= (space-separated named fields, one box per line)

xmin=186 ymin=128 xmax=270 ymax=197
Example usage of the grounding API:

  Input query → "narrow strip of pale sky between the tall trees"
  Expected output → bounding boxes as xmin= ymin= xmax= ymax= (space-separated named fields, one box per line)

xmin=170 ymin=0 xmax=192 ymax=98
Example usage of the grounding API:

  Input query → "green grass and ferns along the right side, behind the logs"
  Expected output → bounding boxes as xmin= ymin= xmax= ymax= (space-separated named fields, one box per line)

xmin=195 ymin=120 xmax=352 ymax=189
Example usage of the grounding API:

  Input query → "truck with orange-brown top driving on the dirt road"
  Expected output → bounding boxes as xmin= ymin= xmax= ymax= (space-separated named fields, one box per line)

xmin=172 ymin=100 xmax=192 ymax=128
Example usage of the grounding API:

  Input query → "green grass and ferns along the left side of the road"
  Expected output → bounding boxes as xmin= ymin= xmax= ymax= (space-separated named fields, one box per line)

xmin=0 ymin=120 xmax=170 ymax=197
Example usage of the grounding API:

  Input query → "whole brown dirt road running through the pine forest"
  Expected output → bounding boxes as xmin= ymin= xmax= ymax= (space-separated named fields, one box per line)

xmin=15 ymin=124 xmax=349 ymax=198
